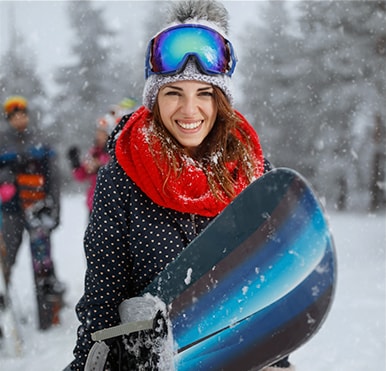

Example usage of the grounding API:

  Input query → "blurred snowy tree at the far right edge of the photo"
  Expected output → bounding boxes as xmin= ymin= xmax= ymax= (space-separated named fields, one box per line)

xmin=300 ymin=1 xmax=386 ymax=209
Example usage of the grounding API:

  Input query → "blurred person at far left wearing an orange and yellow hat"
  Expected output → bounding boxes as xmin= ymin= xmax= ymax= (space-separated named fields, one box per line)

xmin=0 ymin=96 xmax=64 ymax=329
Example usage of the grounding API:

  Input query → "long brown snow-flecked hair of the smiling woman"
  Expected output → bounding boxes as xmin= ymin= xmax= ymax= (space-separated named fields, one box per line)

xmin=150 ymin=86 xmax=254 ymax=199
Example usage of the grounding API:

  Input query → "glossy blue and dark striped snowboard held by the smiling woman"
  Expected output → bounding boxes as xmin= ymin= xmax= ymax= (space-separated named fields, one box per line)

xmin=89 ymin=168 xmax=336 ymax=371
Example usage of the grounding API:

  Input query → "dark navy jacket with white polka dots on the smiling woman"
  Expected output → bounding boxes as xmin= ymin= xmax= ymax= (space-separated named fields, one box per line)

xmin=71 ymin=161 xmax=211 ymax=370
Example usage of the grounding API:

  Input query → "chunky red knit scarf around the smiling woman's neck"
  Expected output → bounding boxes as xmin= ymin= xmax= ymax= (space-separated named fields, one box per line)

xmin=116 ymin=107 xmax=264 ymax=217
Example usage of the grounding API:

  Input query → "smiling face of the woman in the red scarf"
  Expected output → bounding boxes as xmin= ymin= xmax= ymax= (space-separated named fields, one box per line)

xmin=158 ymin=81 xmax=217 ymax=154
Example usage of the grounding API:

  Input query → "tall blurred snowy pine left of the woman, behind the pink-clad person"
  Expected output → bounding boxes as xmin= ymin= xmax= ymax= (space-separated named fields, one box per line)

xmin=53 ymin=0 xmax=122 ymax=182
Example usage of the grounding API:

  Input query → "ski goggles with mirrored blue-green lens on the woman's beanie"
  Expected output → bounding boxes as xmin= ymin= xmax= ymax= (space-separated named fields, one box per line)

xmin=145 ymin=24 xmax=237 ymax=78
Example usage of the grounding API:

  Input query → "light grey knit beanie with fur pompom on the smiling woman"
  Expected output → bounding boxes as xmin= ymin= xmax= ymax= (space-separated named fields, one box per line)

xmin=143 ymin=0 xmax=233 ymax=110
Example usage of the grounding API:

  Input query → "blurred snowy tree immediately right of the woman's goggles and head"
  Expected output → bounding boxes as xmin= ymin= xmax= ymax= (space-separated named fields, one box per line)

xmin=238 ymin=2 xmax=313 ymax=174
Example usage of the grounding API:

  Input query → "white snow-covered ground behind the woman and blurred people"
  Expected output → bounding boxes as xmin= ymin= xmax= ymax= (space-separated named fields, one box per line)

xmin=1 ymin=195 xmax=386 ymax=371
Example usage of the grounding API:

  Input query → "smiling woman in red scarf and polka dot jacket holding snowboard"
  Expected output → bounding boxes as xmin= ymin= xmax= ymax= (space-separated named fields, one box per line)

xmin=71 ymin=0 xmax=292 ymax=371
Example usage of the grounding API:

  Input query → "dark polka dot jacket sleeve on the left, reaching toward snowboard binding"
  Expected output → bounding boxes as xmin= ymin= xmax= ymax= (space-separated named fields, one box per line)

xmin=71 ymin=164 xmax=131 ymax=370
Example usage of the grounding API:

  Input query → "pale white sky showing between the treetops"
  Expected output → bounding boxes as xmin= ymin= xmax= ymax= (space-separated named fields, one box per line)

xmin=0 ymin=0 xmax=258 ymax=94
